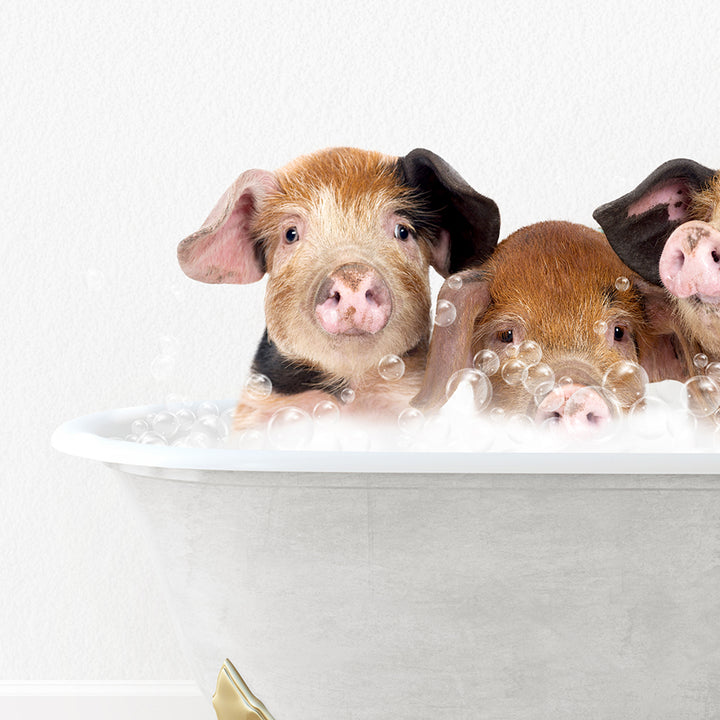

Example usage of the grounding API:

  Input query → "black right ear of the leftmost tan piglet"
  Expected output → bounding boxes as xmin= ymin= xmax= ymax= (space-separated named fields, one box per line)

xmin=398 ymin=148 xmax=500 ymax=277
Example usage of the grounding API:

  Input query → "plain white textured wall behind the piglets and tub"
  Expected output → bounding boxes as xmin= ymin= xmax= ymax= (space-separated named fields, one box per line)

xmin=0 ymin=0 xmax=720 ymax=708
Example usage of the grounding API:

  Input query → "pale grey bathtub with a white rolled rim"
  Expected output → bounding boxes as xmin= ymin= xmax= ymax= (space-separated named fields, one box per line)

xmin=53 ymin=400 xmax=720 ymax=720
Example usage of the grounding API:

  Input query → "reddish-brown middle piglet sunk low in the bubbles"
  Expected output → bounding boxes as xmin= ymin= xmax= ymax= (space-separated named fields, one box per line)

xmin=413 ymin=222 xmax=681 ymax=436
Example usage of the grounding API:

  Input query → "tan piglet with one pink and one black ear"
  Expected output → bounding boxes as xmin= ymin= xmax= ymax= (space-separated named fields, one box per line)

xmin=178 ymin=148 xmax=500 ymax=429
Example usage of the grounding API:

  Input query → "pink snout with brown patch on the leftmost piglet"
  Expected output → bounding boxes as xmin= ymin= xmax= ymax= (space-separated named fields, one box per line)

xmin=315 ymin=263 xmax=392 ymax=335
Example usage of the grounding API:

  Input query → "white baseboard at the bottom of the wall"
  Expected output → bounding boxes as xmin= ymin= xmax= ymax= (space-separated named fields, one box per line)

xmin=0 ymin=684 xmax=217 ymax=720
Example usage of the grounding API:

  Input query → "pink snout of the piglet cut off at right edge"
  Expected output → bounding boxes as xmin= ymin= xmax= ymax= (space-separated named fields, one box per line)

xmin=659 ymin=221 xmax=720 ymax=302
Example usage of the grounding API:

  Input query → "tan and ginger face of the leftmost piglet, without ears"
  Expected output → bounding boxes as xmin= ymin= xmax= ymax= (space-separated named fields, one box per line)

xmin=256 ymin=158 xmax=438 ymax=377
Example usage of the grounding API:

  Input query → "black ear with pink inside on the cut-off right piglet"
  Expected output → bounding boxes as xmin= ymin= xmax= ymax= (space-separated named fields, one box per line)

xmin=593 ymin=159 xmax=715 ymax=285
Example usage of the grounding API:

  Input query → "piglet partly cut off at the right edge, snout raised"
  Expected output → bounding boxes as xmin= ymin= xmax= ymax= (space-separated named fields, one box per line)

xmin=593 ymin=159 xmax=720 ymax=366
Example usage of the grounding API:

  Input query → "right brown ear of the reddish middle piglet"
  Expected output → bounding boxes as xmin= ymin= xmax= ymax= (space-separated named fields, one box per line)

xmin=633 ymin=278 xmax=699 ymax=382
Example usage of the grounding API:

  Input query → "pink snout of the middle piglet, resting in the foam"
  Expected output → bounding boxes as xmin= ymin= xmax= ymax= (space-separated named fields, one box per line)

xmin=535 ymin=384 xmax=612 ymax=437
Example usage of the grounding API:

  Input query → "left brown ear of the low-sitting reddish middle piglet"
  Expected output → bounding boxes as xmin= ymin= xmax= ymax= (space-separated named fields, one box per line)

xmin=410 ymin=270 xmax=490 ymax=410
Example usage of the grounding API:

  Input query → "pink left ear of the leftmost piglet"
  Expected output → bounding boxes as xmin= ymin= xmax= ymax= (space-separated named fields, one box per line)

xmin=178 ymin=170 xmax=277 ymax=283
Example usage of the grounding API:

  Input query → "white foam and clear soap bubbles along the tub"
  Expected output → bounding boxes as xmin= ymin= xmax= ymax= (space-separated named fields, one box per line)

xmin=116 ymin=275 xmax=720 ymax=451
